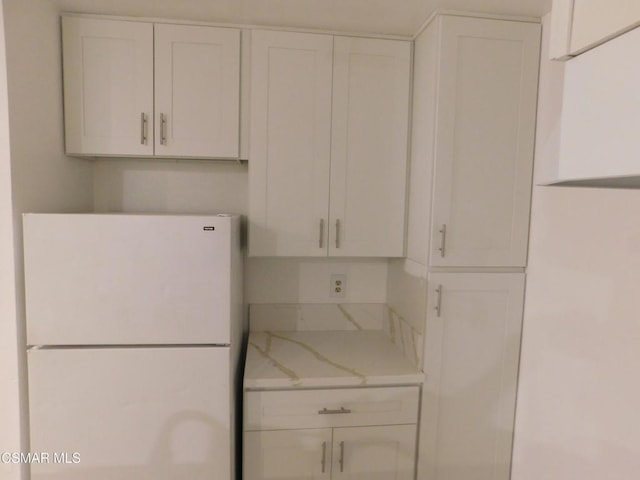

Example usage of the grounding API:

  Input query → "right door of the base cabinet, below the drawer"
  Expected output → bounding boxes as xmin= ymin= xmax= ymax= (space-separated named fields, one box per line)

xmin=332 ymin=425 xmax=416 ymax=480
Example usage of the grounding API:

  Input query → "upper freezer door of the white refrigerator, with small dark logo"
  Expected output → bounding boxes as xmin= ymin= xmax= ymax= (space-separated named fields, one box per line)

xmin=24 ymin=214 xmax=239 ymax=345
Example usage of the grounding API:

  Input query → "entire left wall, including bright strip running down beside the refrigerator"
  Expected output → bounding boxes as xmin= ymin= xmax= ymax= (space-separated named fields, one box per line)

xmin=0 ymin=0 xmax=93 ymax=480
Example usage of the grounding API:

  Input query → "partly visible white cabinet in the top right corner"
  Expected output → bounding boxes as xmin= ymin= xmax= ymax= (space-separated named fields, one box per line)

xmin=549 ymin=0 xmax=640 ymax=59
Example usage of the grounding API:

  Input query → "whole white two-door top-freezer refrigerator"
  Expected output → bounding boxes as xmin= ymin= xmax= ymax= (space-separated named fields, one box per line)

xmin=24 ymin=214 xmax=244 ymax=480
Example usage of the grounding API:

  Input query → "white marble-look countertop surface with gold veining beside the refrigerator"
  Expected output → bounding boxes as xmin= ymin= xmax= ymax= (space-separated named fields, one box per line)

xmin=244 ymin=330 xmax=423 ymax=390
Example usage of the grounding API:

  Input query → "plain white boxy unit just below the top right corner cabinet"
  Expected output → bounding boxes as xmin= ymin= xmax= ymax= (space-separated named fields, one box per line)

xmin=557 ymin=24 xmax=640 ymax=187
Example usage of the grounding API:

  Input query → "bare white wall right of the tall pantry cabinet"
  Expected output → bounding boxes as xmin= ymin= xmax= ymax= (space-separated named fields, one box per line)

xmin=511 ymin=13 xmax=640 ymax=480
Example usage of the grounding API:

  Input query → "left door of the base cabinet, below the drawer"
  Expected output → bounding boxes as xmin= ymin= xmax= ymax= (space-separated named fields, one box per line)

xmin=243 ymin=428 xmax=331 ymax=480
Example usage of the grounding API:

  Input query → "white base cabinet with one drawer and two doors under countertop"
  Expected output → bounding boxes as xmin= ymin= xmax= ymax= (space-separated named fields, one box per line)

xmin=243 ymin=387 xmax=419 ymax=480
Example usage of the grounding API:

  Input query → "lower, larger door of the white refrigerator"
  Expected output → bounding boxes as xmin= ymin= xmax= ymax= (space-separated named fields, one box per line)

xmin=28 ymin=347 xmax=232 ymax=480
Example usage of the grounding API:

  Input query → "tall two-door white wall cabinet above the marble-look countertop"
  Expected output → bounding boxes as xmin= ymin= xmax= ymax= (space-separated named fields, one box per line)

xmin=249 ymin=31 xmax=411 ymax=257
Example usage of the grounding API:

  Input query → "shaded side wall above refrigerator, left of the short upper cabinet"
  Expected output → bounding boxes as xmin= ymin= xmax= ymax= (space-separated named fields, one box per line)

xmin=3 ymin=0 xmax=93 ymax=213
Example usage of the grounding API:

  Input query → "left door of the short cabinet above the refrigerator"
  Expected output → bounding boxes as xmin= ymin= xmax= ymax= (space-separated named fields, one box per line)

xmin=62 ymin=17 xmax=153 ymax=156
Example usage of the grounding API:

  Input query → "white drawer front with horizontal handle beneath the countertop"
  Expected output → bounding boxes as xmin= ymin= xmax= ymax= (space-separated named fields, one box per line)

xmin=244 ymin=386 xmax=420 ymax=431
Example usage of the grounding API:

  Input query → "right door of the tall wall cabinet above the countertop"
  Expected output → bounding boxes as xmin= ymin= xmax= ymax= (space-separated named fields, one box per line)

xmin=329 ymin=37 xmax=411 ymax=257
